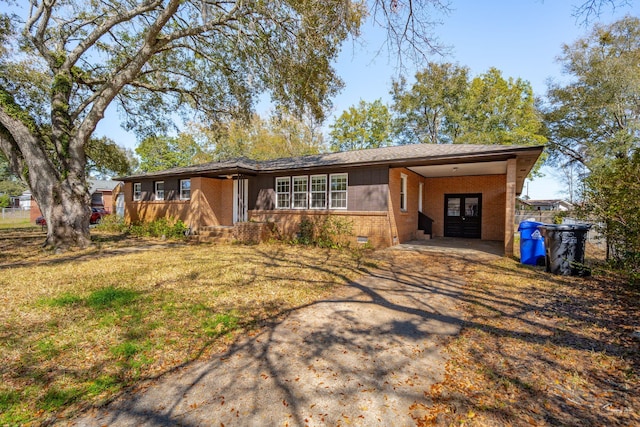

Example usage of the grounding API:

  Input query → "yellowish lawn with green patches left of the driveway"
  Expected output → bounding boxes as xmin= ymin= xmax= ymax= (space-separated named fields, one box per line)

xmin=0 ymin=229 xmax=370 ymax=425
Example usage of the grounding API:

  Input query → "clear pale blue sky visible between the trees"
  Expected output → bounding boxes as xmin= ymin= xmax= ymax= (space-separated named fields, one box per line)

xmin=97 ymin=0 xmax=640 ymax=199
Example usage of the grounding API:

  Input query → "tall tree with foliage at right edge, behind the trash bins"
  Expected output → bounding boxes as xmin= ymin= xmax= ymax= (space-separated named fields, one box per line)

xmin=545 ymin=17 xmax=640 ymax=274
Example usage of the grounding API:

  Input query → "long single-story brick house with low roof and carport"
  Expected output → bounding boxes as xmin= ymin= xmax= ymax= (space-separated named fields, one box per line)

xmin=119 ymin=144 xmax=543 ymax=254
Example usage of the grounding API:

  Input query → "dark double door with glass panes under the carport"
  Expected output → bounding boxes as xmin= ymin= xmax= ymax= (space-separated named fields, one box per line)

xmin=444 ymin=194 xmax=482 ymax=239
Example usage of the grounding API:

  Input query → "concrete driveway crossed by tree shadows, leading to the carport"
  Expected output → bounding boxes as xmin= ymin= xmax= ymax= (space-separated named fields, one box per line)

xmin=72 ymin=239 xmax=496 ymax=426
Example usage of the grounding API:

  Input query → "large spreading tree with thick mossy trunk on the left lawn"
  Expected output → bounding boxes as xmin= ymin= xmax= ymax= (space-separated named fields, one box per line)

xmin=0 ymin=0 xmax=366 ymax=247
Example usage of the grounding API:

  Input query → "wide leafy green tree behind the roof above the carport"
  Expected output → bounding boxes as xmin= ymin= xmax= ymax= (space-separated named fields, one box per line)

xmin=392 ymin=63 xmax=546 ymax=156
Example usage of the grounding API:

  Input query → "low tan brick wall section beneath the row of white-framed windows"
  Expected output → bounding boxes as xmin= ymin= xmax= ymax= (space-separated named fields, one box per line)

xmin=249 ymin=209 xmax=392 ymax=248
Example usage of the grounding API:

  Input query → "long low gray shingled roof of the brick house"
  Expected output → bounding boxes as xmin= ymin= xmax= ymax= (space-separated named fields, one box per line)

xmin=118 ymin=144 xmax=543 ymax=181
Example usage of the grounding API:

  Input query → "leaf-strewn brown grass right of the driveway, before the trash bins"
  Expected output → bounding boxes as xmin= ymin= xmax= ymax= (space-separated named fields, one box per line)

xmin=404 ymin=248 xmax=640 ymax=426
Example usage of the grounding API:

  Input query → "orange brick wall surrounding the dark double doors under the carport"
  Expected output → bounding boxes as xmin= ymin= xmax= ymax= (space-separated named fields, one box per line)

xmin=423 ymin=175 xmax=506 ymax=241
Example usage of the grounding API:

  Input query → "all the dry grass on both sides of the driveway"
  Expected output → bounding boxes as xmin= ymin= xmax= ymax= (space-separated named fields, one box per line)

xmin=0 ymin=229 xmax=640 ymax=426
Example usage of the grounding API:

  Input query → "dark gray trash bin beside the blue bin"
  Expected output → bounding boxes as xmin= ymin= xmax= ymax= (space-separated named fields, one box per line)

xmin=538 ymin=224 xmax=591 ymax=276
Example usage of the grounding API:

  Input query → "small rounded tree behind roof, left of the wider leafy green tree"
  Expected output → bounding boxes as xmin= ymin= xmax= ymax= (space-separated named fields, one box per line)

xmin=329 ymin=99 xmax=393 ymax=151
